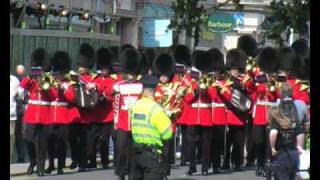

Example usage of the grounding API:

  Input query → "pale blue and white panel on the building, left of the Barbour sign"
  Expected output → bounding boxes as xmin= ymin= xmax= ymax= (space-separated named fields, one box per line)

xmin=143 ymin=19 xmax=172 ymax=47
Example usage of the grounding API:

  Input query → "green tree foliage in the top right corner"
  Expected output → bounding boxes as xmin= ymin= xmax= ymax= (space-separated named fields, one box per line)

xmin=261 ymin=0 xmax=310 ymax=47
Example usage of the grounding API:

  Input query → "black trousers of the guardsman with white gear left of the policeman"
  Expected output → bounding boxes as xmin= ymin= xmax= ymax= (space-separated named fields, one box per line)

xmin=115 ymin=129 xmax=131 ymax=176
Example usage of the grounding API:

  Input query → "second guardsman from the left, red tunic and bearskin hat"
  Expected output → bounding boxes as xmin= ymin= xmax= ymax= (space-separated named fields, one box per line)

xmin=46 ymin=51 xmax=75 ymax=174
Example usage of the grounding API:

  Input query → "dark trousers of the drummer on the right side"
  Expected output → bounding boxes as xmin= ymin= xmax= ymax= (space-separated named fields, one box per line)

xmin=224 ymin=125 xmax=245 ymax=166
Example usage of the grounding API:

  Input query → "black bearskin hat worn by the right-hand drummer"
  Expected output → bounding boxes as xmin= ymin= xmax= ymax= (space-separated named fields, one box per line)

xmin=226 ymin=48 xmax=247 ymax=70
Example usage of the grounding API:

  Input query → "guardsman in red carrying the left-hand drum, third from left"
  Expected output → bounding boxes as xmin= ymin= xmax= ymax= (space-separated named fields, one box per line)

xmin=69 ymin=44 xmax=96 ymax=172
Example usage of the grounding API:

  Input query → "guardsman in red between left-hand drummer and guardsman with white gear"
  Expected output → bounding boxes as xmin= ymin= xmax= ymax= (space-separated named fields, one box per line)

xmin=88 ymin=47 xmax=116 ymax=169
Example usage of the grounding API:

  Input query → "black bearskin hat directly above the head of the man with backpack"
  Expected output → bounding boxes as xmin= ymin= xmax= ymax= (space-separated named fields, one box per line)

xmin=279 ymin=47 xmax=299 ymax=71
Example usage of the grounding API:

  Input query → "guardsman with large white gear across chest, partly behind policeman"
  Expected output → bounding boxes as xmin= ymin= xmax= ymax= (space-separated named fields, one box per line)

xmin=113 ymin=48 xmax=143 ymax=179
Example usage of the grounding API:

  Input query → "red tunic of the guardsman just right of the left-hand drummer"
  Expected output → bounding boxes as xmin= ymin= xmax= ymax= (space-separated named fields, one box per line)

xmin=94 ymin=76 xmax=115 ymax=123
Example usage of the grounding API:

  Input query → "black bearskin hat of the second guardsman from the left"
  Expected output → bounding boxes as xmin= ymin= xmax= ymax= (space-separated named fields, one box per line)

xmin=51 ymin=51 xmax=71 ymax=74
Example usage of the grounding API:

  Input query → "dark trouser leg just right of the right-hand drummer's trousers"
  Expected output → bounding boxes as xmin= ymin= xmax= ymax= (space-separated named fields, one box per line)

xmin=245 ymin=116 xmax=256 ymax=164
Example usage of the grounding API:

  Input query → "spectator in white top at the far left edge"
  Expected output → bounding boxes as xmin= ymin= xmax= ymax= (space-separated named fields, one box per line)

xmin=10 ymin=75 xmax=20 ymax=162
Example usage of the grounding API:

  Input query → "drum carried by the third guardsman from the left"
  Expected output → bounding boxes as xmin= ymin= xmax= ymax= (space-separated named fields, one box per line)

xmin=75 ymin=83 xmax=99 ymax=109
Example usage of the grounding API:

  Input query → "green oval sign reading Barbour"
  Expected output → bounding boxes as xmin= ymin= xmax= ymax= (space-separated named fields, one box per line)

xmin=207 ymin=11 xmax=236 ymax=33
